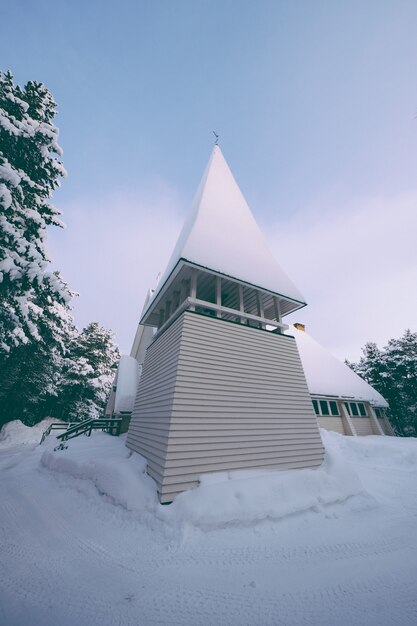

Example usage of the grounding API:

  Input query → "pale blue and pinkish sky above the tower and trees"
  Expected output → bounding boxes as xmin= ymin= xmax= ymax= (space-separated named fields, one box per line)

xmin=0 ymin=0 xmax=417 ymax=360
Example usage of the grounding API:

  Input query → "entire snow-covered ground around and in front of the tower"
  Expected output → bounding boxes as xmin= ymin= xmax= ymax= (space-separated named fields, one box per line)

xmin=0 ymin=423 xmax=417 ymax=626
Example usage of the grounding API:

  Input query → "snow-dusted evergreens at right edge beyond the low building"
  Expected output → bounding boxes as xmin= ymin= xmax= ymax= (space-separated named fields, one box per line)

xmin=347 ymin=330 xmax=417 ymax=436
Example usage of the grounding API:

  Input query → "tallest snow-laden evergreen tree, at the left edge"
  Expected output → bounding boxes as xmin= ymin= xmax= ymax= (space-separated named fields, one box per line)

xmin=0 ymin=72 xmax=74 ymax=424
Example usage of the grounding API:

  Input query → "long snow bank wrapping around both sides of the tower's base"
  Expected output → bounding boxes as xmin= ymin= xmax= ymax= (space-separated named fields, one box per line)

xmin=41 ymin=433 xmax=366 ymax=530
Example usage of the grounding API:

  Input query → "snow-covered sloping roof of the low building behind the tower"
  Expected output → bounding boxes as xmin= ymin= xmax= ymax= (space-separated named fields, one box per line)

xmin=287 ymin=326 xmax=388 ymax=407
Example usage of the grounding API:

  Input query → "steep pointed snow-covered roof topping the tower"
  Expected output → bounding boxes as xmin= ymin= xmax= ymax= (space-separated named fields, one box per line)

xmin=146 ymin=145 xmax=305 ymax=312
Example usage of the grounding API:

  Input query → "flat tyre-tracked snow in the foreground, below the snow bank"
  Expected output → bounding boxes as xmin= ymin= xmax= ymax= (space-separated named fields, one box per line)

xmin=0 ymin=446 xmax=417 ymax=626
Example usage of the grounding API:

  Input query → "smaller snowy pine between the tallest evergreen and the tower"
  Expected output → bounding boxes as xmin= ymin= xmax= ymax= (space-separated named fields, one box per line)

xmin=54 ymin=322 xmax=120 ymax=421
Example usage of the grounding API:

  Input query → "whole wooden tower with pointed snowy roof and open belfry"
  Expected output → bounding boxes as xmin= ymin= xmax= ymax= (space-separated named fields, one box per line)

xmin=126 ymin=145 xmax=323 ymax=502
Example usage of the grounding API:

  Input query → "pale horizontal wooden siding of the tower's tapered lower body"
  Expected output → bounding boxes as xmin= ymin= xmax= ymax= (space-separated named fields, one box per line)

xmin=127 ymin=312 xmax=323 ymax=502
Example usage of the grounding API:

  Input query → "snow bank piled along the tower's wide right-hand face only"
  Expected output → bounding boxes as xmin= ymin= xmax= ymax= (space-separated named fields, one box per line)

xmin=167 ymin=449 xmax=365 ymax=530
